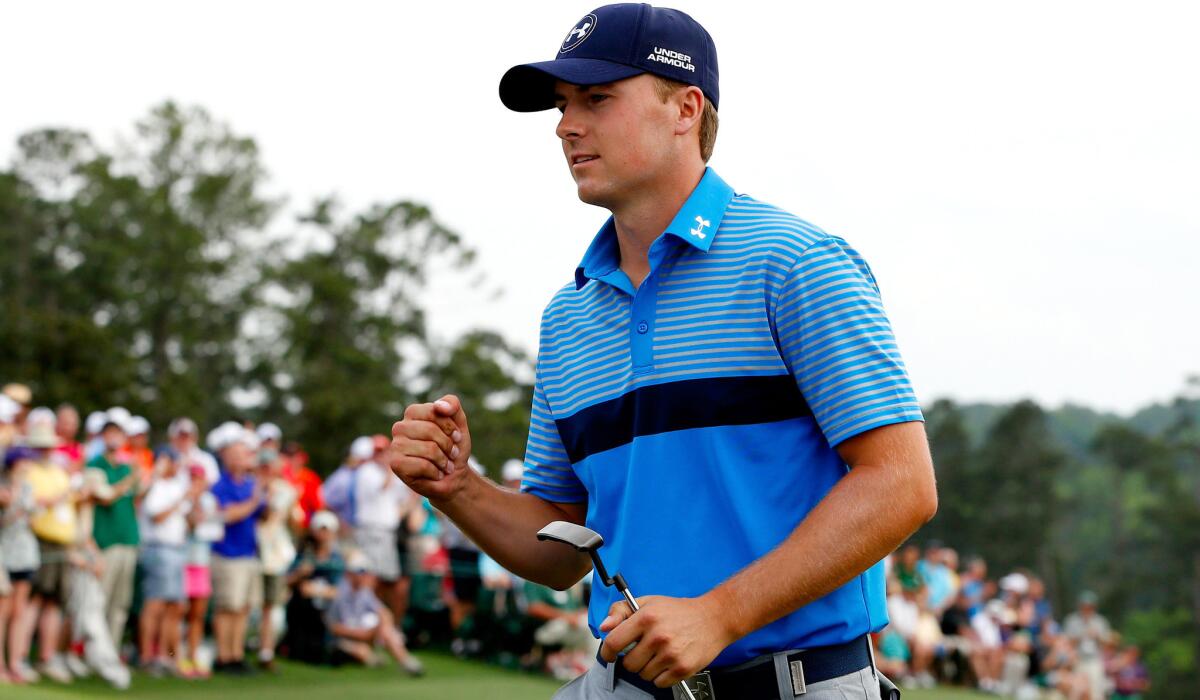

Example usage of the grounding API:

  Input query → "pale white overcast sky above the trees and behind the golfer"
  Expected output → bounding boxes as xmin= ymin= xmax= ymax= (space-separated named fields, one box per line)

xmin=0 ymin=0 xmax=1200 ymax=412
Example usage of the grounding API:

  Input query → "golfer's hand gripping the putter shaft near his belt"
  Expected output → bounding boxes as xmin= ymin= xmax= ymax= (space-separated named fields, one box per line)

xmin=600 ymin=596 xmax=736 ymax=688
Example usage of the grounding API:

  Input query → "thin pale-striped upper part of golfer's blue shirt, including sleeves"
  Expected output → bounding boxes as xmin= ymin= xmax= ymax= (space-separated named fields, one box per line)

xmin=523 ymin=188 xmax=922 ymax=502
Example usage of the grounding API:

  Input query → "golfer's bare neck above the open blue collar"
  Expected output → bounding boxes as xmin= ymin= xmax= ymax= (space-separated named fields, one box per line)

xmin=611 ymin=156 xmax=704 ymax=287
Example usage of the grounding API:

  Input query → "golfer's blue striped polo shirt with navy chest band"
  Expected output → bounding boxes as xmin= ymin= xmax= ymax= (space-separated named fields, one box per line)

xmin=521 ymin=169 xmax=923 ymax=666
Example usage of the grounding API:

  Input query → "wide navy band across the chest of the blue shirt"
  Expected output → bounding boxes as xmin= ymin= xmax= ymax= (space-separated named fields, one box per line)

xmin=554 ymin=375 xmax=812 ymax=463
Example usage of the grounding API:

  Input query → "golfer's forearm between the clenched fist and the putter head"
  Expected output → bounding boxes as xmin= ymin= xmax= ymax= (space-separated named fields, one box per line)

xmin=432 ymin=477 xmax=592 ymax=590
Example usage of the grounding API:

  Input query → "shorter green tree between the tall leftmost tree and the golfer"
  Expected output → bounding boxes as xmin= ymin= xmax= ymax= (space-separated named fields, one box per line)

xmin=248 ymin=198 xmax=473 ymax=472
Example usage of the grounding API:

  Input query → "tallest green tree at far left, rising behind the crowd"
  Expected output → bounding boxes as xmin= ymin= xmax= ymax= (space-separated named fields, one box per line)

xmin=0 ymin=102 xmax=275 ymax=426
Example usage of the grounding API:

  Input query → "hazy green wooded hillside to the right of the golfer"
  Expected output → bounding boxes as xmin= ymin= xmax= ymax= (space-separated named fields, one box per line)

xmin=917 ymin=387 xmax=1200 ymax=698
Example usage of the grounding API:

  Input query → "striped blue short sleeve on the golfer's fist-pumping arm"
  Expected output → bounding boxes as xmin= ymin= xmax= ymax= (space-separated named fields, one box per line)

xmin=521 ymin=371 xmax=588 ymax=503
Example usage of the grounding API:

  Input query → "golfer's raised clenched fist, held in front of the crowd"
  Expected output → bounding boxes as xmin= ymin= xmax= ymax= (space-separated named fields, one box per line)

xmin=391 ymin=394 xmax=475 ymax=503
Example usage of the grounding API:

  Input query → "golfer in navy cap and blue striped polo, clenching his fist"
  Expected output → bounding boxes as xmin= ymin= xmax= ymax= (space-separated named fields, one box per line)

xmin=392 ymin=5 xmax=937 ymax=700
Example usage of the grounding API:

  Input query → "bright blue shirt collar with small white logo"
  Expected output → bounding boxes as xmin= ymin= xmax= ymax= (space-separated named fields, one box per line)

xmin=575 ymin=168 xmax=733 ymax=289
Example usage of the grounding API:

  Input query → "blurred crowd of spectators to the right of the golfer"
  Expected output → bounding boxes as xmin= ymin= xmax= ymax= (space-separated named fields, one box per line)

xmin=876 ymin=543 xmax=1150 ymax=700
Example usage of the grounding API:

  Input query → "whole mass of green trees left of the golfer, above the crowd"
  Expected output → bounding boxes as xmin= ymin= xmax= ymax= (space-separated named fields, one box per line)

xmin=0 ymin=102 xmax=530 ymax=472
